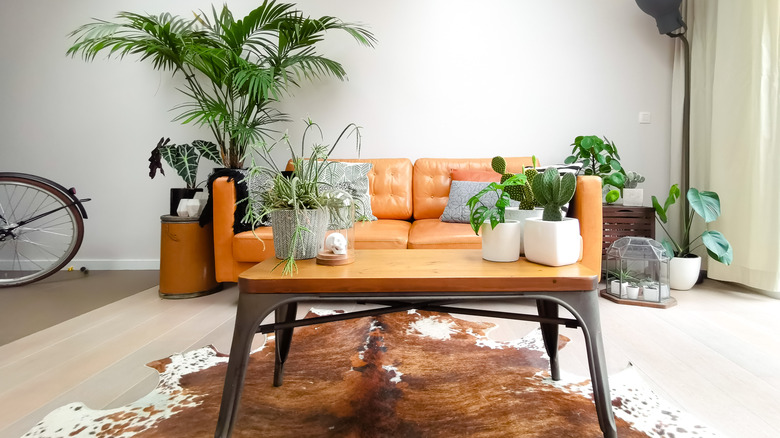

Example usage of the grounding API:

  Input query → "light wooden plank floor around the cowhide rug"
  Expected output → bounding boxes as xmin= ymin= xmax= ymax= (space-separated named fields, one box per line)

xmin=0 ymin=281 xmax=780 ymax=438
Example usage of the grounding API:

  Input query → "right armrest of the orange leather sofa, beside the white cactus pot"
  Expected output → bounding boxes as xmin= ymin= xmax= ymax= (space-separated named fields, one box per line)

xmin=569 ymin=176 xmax=604 ymax=279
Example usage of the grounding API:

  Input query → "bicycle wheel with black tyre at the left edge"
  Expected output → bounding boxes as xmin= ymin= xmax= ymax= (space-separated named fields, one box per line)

xmin=0 ymin=176 xmax=84 ymax=287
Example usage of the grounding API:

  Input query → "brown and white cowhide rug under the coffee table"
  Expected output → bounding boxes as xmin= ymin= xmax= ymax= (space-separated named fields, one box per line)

xmin=24 ymin=310 xmax=715 ymax=438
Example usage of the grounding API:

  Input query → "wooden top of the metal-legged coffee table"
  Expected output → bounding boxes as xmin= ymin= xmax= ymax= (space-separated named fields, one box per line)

xmin=238 ymin=249 xmax=598 ymax=294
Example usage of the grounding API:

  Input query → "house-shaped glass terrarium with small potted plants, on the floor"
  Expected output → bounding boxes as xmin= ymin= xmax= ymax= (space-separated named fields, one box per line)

xmin=604 ymin=237 xmax=674 ymax=307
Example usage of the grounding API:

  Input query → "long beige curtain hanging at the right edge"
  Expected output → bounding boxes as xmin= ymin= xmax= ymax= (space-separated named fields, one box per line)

xmin=684 ymin=0 xmax=780 ymax=297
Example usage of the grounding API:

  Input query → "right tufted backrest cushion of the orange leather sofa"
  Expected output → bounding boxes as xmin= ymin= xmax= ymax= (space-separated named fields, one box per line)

xmin=414 ymin=157 xmax=531 ymax=219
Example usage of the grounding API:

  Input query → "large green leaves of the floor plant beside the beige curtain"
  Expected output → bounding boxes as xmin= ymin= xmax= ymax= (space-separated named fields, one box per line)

xmin=652 ymin=184 xmax=734 ymax=265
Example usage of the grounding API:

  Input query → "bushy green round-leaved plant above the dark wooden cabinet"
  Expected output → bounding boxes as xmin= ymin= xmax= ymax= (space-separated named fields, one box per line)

xmin=564 ymin=135 xmax=626 ymax=204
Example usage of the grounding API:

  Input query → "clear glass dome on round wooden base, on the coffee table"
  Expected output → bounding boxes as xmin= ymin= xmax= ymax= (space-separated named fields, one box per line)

xmin=317 ymin=189 xmax=355 ymax=266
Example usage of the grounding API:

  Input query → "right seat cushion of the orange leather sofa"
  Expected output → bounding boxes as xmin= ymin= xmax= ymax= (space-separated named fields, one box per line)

xmin=408 ymin=219 xmax=482 ymax=249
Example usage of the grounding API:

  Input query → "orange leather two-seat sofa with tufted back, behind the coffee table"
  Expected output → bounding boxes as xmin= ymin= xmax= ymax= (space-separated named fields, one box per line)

xmin=212 ymin=157 xmax=602 ymax=282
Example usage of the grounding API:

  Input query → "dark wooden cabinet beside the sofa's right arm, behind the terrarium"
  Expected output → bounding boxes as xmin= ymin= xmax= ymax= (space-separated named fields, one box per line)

xmin=601 ymin=204 xmax=655 ymax=257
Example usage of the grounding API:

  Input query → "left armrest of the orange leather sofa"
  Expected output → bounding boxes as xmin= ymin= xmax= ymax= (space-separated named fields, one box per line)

xmin=211 ymin=176 xmax=236 ymax=282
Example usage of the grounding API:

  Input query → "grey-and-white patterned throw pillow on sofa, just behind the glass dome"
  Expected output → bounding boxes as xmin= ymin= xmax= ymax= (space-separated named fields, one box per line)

xmin=320 ymin=161 xmax=377 ymax=221
